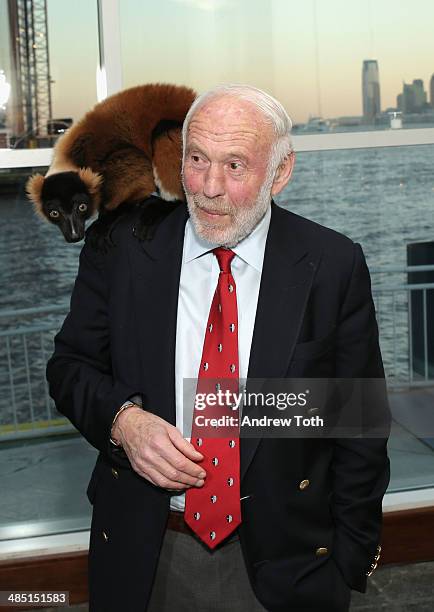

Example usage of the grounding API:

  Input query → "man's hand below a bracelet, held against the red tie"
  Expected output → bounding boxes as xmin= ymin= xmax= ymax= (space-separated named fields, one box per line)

xmin=112 ymin=406 xmax=206 ymax=491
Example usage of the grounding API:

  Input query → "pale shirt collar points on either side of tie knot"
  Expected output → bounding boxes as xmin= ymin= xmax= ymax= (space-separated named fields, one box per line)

xmin=184 ymin=206 xmax=271 ymax=272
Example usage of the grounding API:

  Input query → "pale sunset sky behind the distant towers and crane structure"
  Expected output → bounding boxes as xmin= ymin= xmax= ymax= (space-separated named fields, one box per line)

xmin=0 ymin=0 xmax=434 ymax=122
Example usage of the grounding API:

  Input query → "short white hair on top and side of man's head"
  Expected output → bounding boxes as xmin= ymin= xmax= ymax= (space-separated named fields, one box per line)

xmin=182 ymin=83 xmax=294 ymax=176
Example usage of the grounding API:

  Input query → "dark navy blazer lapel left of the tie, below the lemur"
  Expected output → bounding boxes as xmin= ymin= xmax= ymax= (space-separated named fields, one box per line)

xmin=125 ymin=206 xmax=188 ymax=425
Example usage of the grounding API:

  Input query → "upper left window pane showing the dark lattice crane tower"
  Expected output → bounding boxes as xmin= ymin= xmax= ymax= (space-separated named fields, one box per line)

xmin=0 ymin=0 xmax=99 ymax=149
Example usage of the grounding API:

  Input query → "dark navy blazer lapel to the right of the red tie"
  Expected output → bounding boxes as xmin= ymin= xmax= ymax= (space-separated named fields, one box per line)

xmin=240 ymin=203 xmax=321 ymax=478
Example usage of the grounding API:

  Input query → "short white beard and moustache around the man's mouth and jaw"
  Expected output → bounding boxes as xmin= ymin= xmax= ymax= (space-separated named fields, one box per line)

xmin=184 ymin=175 xmax=274 ymax=248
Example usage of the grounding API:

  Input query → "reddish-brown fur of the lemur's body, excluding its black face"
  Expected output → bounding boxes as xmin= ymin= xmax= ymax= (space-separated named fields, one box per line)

xmin=27 ymin=84 xmax=196 ymax=214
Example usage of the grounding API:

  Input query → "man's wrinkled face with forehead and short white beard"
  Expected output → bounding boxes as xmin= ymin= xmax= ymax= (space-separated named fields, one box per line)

xmin=183 ymin=96 xmax=274 ymax=247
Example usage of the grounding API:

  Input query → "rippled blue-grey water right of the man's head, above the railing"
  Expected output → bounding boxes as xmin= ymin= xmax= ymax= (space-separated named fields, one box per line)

xmin=277 ymin=145 xmax=434 ymax=267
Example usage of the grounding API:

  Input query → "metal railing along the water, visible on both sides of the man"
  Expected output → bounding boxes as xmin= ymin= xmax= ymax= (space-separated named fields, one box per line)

xmin=0 ymin=265 xmax=434 ymax=440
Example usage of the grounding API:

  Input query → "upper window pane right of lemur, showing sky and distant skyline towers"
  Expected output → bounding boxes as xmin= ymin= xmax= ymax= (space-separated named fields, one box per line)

xmin=120 ymin=0 xmax=434 ymax=134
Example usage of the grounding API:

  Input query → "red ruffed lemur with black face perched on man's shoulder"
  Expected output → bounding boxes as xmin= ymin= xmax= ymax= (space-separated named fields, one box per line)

xmin=27 ymin=84 xmax=196 ymax=242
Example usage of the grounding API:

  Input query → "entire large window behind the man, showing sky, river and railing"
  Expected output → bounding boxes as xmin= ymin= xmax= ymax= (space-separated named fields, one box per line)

xmin=0 ymin=0 xmax=434 ymax=540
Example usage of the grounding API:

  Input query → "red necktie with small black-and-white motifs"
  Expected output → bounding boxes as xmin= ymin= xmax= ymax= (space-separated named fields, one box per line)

xmin=184 ymin=248 xmax=241 ymax=548
